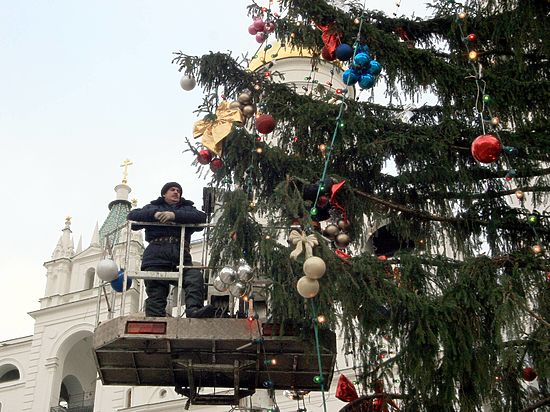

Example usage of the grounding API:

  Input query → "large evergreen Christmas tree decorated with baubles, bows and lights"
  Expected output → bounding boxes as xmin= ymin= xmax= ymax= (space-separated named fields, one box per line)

xmin=174 ymin=0 xmax=550 ymax=411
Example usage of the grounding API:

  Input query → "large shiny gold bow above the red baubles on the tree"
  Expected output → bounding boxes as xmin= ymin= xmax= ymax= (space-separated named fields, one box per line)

xmin=193 ymin=100 xmax=243 ymax=156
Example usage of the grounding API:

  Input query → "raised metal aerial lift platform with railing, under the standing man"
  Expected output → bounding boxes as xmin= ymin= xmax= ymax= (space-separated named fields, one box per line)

xmin=93 ymin=219 xmax=336 ymax=405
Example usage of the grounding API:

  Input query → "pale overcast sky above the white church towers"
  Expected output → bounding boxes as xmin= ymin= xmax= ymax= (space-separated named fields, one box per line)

xmin=0 ymin=0 xmax=430 ymax=341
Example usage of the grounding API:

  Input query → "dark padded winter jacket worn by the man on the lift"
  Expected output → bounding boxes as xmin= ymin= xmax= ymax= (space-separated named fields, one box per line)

xmin=128 ymin=197 xmax=206 ymax=270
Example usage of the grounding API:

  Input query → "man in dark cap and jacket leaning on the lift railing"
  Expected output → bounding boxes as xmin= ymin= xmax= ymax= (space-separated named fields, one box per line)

xmin=128 ymin=182 xmax=215 ymax=318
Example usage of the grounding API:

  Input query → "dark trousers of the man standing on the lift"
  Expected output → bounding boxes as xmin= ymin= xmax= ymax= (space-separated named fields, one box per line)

xmin=143 ymin=262 xmax=204 ymax=317
